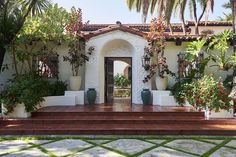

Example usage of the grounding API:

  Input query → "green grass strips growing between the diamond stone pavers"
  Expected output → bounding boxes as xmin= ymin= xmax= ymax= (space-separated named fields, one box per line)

xmin=0 ymin=136 xmax=236 ymax=157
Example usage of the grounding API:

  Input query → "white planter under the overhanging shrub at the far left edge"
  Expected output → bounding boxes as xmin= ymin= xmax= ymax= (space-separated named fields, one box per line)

xmin=3 ymin=104 xmax=31 ymax=118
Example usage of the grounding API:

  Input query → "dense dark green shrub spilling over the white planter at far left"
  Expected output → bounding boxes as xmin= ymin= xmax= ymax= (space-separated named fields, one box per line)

xmin=0 ymin=74 xmax=66 ymax=113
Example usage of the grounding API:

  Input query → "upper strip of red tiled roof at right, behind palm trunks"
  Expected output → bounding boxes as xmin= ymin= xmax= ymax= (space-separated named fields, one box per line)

xmin=186 ymin=21 xmax=232 ymax=26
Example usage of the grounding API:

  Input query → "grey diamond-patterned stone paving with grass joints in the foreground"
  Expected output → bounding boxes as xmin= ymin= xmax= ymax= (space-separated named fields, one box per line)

xmin=0 ymin=137 xmax=236 ymax=157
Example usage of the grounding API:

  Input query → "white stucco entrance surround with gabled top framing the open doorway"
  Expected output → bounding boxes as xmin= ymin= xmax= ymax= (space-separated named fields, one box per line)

xmin=85 ymin=31 xmax=151 ymax=104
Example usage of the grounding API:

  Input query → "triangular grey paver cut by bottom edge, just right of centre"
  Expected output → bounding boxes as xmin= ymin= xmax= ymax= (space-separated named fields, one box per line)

xmin=139 ymin=147 xmax=194 ymax=157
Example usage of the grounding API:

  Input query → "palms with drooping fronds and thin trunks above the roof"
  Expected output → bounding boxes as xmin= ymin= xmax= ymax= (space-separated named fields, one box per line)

xmin=127 ymin=0 xmax=214 ymax=35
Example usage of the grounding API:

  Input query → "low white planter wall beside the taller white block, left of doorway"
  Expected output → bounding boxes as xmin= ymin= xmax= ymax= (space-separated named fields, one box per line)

xmin=39 ymin=96 xmax=75 ymax=108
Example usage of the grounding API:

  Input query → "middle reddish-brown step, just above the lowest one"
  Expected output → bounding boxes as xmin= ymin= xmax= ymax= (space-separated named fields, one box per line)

xmin=1 ymin=117 xmax=236 ymax=125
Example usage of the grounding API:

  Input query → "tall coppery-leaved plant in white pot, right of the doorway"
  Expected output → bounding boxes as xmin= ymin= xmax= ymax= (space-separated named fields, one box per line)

xmin=143 ymin=18 xmax=175 ymax=90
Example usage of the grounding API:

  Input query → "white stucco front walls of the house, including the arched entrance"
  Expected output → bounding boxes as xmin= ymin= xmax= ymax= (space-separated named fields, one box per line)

xmin=0 ymin=27 xmax=232 ymax=104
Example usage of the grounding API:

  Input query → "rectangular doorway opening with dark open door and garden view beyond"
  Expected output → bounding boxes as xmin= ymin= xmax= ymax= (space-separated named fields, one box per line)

xmin=104 ymin=57 xmax=132 ymax=104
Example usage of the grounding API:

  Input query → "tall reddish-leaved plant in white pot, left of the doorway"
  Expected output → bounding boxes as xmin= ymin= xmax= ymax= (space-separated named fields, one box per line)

xmin=63 ymin=7 xmax=94 ymax=91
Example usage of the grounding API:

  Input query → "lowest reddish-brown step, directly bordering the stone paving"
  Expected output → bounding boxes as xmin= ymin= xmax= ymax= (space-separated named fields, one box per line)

xmin=0 ymin=124 xmax=236 ymax=136
